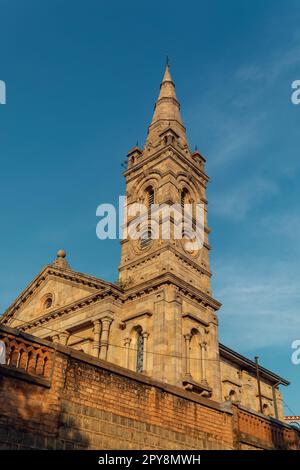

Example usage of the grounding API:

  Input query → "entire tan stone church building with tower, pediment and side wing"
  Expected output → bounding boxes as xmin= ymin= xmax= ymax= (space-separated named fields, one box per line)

xmin=1 ymin=66 xmax=288 ymax=426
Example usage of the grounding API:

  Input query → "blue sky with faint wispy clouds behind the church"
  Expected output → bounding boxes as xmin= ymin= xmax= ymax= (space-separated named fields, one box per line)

xmin=0 ymin=0 xmax=300 ymax=414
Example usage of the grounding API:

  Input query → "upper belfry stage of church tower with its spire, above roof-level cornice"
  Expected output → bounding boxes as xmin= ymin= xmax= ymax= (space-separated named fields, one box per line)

xmin=119 ymin=65 xmax=211 ymax=295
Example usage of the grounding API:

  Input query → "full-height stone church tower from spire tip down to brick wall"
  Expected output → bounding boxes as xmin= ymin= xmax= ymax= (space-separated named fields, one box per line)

xmin=119 ymin=64 xmax=221 ymax=401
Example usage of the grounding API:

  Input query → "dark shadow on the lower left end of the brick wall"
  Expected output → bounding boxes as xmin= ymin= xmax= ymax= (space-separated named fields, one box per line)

xmin=0 ymin=366 xmax=89 ymax=450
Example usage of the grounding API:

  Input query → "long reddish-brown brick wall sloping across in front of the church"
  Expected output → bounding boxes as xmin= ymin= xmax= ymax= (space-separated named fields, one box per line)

xmin=0 ymin=326 xmax=300 ymax=450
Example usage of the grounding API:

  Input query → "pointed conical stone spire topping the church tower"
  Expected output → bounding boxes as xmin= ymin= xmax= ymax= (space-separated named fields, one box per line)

xmin=147 ymin=61 xmax=186 ymax=147
